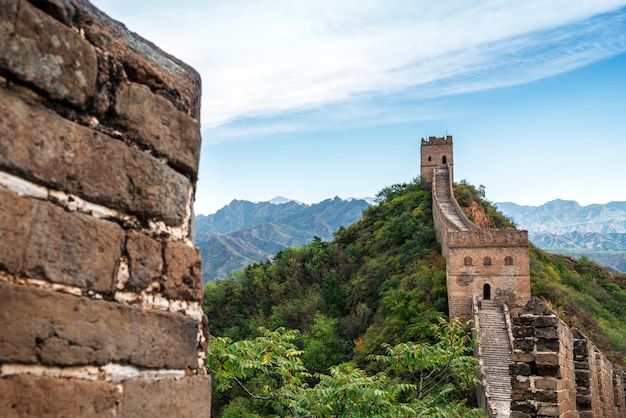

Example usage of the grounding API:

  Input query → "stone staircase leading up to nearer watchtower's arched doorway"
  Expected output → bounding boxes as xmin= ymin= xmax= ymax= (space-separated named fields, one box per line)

xmin=478 ymin=300 xmax=512 ymax=418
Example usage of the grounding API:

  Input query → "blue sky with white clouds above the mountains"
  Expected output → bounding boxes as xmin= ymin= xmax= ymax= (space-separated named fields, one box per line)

xmin=94 ymin=0 xmax=626 ymax=214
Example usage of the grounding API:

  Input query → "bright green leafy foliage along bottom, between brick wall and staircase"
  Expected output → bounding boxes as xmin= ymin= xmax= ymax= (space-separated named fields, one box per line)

xmin=207 ymin=321 xmax=481 ymax=418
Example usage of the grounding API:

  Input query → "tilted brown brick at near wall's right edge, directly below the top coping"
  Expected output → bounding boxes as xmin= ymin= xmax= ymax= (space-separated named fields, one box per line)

xmin=113 ymin=82 xmax=200 ymax=178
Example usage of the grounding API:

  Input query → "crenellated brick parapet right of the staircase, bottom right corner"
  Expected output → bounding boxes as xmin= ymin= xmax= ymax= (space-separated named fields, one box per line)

xmin=510 ymin=298 xmax=626 ymax=418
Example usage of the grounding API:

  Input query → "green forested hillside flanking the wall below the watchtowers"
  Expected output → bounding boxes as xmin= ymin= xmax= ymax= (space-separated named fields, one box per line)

xmin=204 ymin=181 xmax=626 ymax=412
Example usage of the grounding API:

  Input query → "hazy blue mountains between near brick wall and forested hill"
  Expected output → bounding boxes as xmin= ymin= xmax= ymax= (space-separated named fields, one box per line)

xmin=196 ymin=197 xmax=369 ymax=282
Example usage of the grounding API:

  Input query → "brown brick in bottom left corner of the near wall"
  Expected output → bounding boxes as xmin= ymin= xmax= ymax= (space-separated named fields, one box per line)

xmin=0 ymin=374 xmax=121 ymax=418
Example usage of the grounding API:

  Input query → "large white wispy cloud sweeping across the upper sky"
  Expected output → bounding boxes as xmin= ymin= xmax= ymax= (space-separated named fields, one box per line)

xmin=96 ymin=0 xmax=626 ymax=136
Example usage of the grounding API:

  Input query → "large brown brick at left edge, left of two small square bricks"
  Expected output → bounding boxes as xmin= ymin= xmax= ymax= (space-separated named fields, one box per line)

xmin=0 ymin=186 xmax=124 ymax=293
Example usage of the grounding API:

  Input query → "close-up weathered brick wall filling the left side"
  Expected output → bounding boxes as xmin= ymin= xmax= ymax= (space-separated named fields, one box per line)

xmin=0 ymin=0 xmax=211 ymax=417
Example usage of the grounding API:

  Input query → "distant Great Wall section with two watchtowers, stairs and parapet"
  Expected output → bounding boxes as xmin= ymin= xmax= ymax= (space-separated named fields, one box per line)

xmin=421 ymin=136 xmax=626 ymax=418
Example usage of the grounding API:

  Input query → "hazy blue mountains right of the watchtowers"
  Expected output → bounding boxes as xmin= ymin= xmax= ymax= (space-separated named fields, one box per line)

xmin=496 ymin=200 xmax=626 ymax=272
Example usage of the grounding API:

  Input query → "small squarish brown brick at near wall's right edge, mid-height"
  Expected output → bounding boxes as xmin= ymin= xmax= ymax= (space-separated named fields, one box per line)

xmin=162 ymin=242 xmax=203 ymax=302
